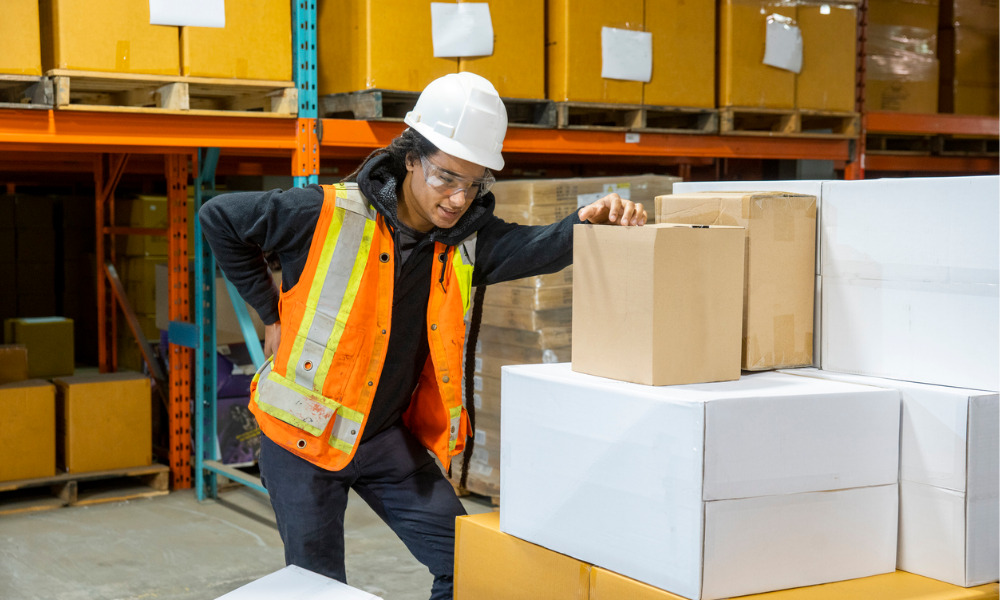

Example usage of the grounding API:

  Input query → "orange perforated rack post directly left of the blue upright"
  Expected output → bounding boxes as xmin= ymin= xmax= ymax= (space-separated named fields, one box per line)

xmin=166 ymin=154 xmax=194 ymax=490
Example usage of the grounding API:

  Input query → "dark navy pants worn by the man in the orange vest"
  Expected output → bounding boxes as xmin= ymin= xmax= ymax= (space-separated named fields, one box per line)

xmin=260 ymin=425 xmax=465 ymax=600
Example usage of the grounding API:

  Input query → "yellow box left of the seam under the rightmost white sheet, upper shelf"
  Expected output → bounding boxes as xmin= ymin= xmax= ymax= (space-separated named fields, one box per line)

xmin=718 ymin=0 xmax=798 ymax=108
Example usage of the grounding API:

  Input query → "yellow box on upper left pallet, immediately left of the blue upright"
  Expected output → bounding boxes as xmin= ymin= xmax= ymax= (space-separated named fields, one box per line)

xmin=181 ymin=0 xmax=292 ymax=81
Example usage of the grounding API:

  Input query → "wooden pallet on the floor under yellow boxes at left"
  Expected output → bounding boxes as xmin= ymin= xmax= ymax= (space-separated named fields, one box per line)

xmin=0 ymin=464 xmax=170 ymax=515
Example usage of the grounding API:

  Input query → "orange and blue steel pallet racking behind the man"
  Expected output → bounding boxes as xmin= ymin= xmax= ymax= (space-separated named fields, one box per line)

xmin=0 ymin=0 xmax=1000 ymax=498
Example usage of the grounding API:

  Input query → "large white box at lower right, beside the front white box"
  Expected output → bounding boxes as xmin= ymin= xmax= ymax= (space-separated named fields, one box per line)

xmin=783 ymin=369 xmax=1000 ymax=587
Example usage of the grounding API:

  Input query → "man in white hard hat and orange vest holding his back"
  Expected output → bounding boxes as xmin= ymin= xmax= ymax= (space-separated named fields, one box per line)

xmin=199 ymin=73 xmax=646 ymax=598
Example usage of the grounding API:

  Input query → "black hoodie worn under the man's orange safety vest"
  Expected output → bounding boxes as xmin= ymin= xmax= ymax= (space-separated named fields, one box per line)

xmin=198 ymin=155 xmax=581 ymax=440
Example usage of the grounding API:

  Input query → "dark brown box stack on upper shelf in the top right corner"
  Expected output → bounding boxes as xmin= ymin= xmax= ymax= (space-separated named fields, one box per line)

xmin=938 ymin=0 xmax=1000 ymax=115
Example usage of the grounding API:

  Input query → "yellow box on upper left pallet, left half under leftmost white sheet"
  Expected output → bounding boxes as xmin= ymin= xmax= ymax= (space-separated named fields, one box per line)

xmin=39 ymin=0 xmax=180 ymax=75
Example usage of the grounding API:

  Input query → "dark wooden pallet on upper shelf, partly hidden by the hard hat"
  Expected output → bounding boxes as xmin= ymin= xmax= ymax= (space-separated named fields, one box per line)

xmin=320 ymin=89 xmax=556 ymax=127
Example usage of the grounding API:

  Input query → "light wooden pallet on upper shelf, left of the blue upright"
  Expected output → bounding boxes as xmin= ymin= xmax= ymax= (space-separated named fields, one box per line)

xmin=47 ymin=69 xmax=298 ymax=118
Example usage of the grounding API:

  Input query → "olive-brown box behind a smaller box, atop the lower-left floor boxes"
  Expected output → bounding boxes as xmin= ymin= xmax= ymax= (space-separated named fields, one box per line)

xmin=3 ymin=317 xmax=74 ymax=379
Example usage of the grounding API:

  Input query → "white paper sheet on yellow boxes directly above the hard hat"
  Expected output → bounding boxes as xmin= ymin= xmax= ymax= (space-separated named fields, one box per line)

xmin=431 ymin=2 xmax=493 ymax=58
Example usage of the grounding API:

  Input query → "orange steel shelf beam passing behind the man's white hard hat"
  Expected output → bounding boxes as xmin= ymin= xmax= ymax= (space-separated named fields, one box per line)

xmin=320 ymin=119 xmax=849 ymax=162
